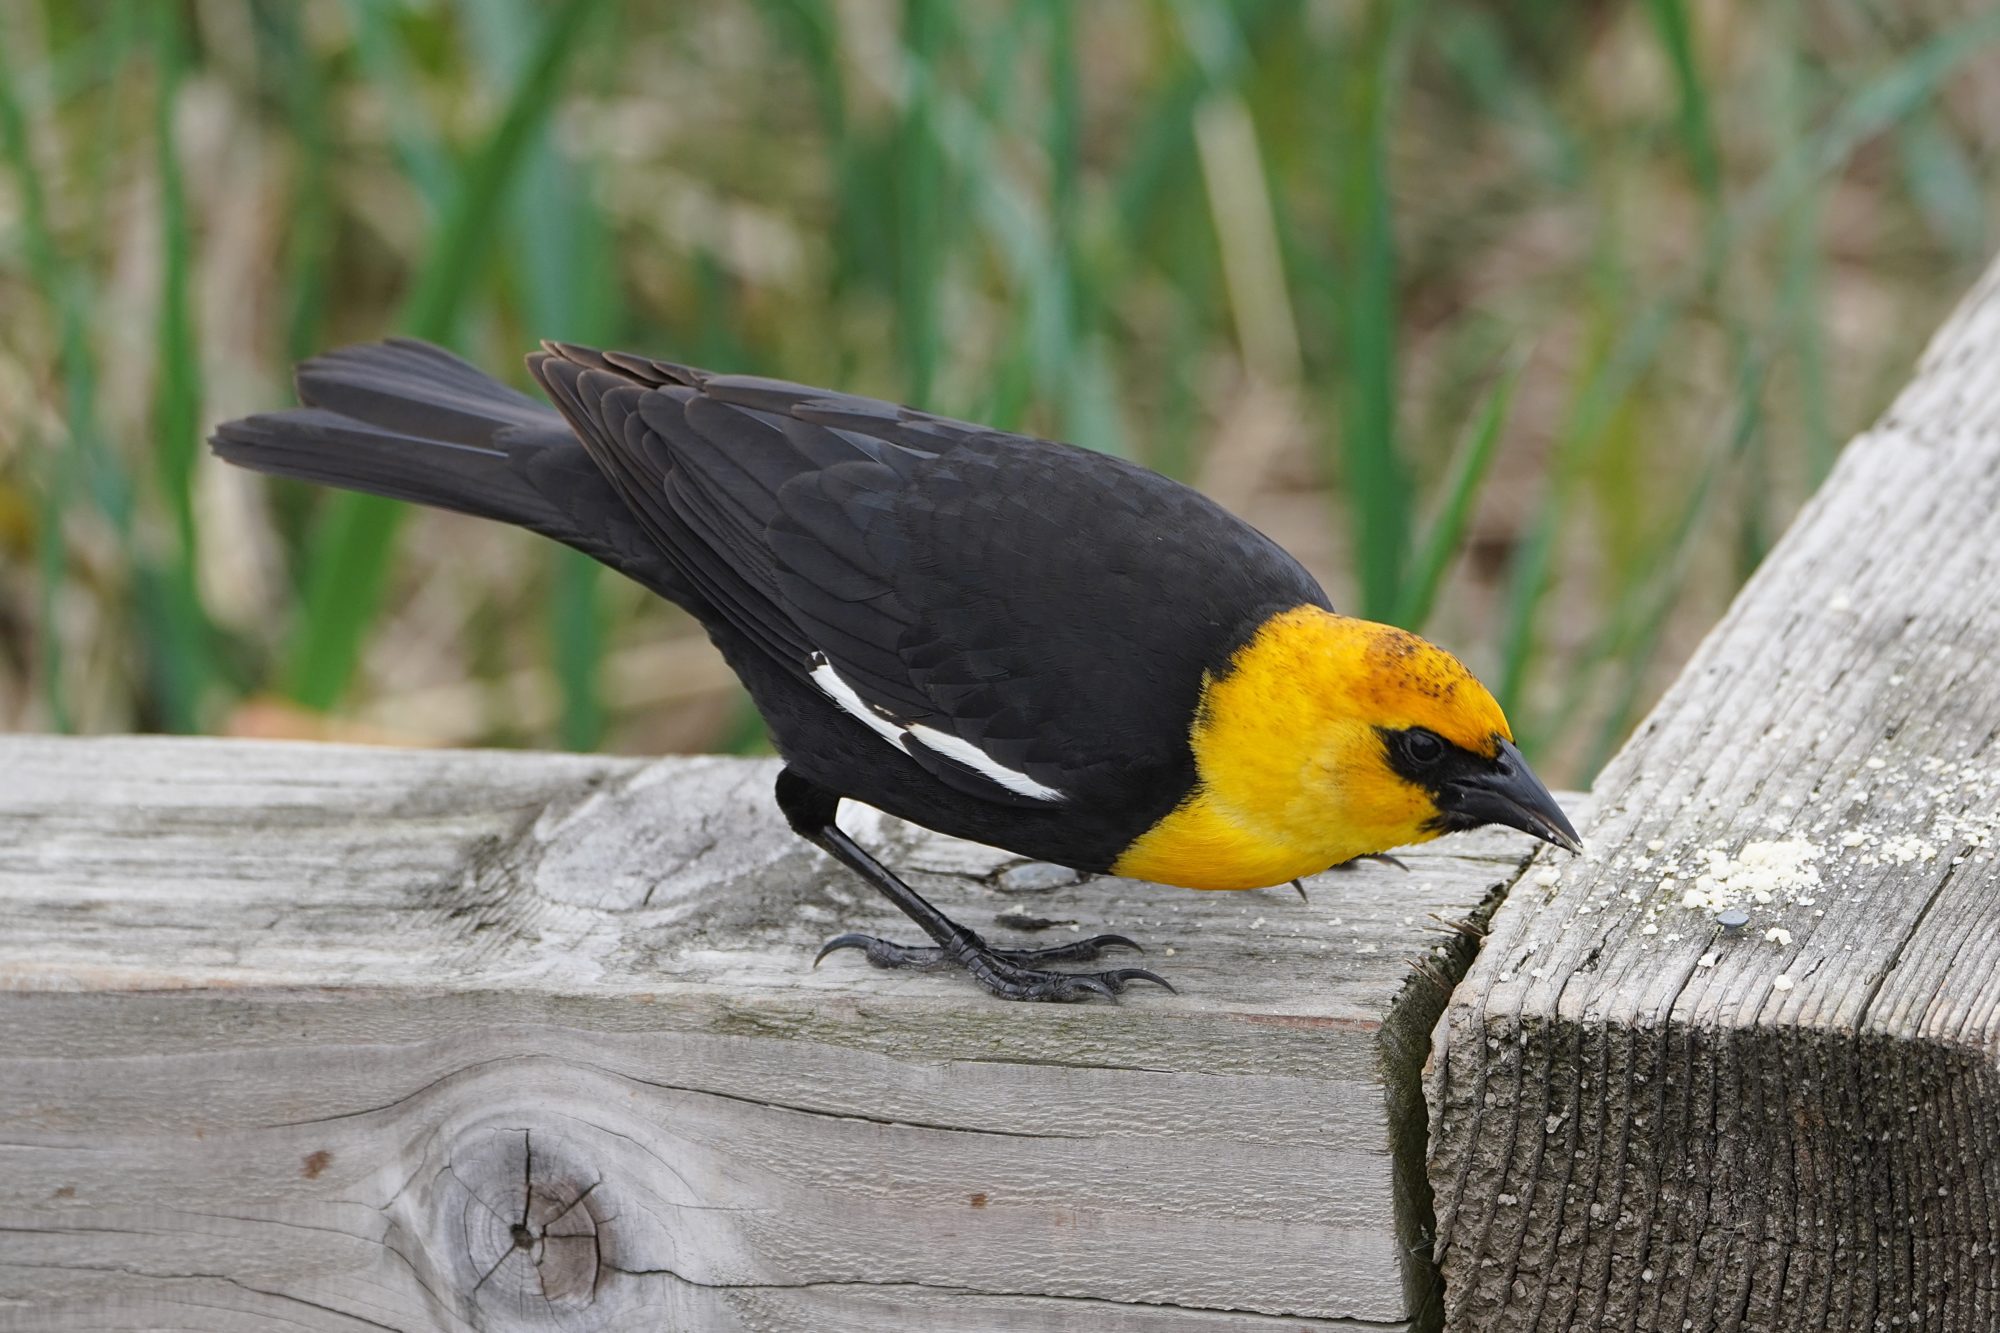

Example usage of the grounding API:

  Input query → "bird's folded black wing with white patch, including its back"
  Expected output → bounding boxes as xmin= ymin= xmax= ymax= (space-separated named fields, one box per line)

xmin=530 ymin=346 xmax=1326 ymax=805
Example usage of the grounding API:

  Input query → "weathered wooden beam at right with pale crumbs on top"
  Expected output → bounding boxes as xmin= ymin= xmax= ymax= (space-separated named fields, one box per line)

xmin=1426 ymin=268 xmax=2000 ymax=1333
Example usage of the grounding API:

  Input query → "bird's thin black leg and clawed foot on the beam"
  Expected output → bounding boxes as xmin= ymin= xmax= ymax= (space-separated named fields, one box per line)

xmin=778 ymin=769 xmax=1174 ymax=1001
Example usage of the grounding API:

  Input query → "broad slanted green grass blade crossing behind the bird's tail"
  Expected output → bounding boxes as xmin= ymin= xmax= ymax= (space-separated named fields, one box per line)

xmin=286 ymin=0 xmax=604 ymax=709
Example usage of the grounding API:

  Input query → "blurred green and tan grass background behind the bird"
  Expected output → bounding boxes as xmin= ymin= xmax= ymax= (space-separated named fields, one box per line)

xmin=0 ymin=0 xmax=2000 ymax=783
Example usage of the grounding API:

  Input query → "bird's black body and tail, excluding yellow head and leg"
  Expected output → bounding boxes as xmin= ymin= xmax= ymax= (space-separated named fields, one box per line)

xmin=216 ymin=342 xmax=1326 ymax=871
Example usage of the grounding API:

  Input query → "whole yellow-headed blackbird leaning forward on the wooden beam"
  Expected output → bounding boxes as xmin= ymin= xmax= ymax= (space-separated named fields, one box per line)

xmin=214 ymin=340 xmax=1578 ymax=1001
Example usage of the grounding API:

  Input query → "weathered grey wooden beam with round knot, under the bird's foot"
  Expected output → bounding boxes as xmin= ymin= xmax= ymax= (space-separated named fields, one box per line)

xmin=0 ymin=739 xmax=1560 ymax=1333
